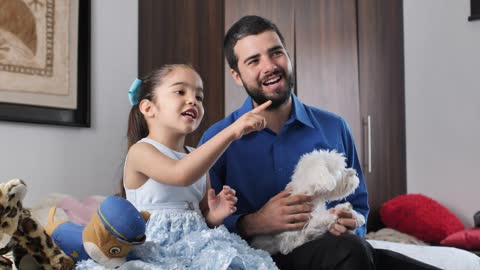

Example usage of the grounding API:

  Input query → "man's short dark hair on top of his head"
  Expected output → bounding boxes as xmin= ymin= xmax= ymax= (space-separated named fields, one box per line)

xmin=223 ymin=16 xmax=285 ymax=72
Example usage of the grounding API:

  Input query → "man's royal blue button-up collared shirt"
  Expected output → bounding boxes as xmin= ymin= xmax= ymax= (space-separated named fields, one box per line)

xmin=200 ymin=95 xmax=369 ymax=236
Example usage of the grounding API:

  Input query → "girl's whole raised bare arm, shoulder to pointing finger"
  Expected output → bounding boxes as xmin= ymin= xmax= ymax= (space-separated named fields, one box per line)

xmin=126 ymin=100 xmax=271 ymax=186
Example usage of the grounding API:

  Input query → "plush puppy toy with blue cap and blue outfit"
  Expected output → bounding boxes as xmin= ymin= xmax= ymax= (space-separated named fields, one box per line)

xmin=45 ymin=196 xmax=150 ymax=268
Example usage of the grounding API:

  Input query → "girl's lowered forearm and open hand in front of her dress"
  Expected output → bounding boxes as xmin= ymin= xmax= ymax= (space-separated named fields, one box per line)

xmin=200 ymin=174 xmax=237 ymax=228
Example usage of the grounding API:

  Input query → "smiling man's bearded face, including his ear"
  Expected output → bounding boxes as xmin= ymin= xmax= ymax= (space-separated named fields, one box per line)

xmin=231 ymin=31 xmax=293 ymax=109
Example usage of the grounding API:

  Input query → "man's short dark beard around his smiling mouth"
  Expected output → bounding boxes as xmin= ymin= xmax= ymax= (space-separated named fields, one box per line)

xmin=242 ymin=69 xmax=294 ymax=110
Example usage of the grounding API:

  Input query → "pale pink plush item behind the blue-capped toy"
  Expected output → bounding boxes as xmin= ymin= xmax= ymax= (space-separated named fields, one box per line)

xmin=57 ymin=196 xmax=105 ymax=225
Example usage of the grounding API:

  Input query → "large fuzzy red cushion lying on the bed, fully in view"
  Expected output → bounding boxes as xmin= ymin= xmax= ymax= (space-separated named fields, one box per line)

xmin=380 ymin=194 xmax=465 ymax=244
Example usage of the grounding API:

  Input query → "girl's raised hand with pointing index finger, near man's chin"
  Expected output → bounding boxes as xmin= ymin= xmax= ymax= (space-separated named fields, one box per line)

xmin=231 ymin=100 xmax=272 ymax=139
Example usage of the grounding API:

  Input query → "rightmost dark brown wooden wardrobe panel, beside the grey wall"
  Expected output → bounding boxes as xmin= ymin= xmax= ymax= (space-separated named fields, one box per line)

xmin=358 ymin=0 xmax=406 ymax=230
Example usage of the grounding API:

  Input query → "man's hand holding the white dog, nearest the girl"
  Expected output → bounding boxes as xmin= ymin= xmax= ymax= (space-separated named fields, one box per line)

xmin=238 ymin=190 xmax=313 ymax=237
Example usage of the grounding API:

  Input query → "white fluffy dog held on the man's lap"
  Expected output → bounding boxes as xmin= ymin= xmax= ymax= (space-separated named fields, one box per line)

xmin=252 ymin=150 xmax=365 ymax=254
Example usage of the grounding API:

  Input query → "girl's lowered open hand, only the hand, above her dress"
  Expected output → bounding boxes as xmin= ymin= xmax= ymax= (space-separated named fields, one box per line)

xmin=208 ymin=186 xmax=237 ymax=225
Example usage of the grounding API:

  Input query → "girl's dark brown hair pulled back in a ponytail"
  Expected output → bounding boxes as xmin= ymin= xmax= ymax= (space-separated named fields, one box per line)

xmin=118 ymin=64 xmax=196 ymax=198
